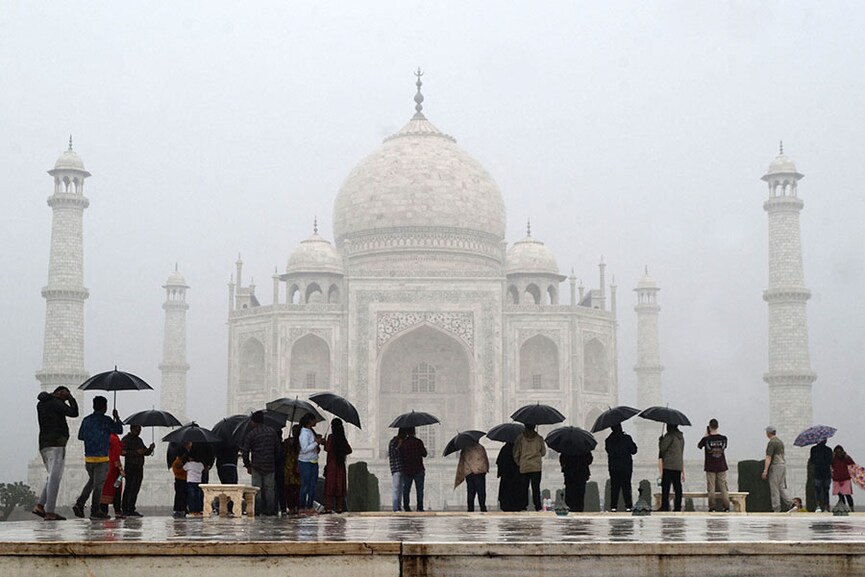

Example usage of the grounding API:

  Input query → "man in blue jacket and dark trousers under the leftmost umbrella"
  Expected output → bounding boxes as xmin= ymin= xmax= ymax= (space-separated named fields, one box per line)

xmin=72 ymin=395 xmax=123 ymax=519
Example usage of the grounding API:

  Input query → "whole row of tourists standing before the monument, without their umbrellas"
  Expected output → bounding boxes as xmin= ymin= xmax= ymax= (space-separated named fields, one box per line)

xmin=33 ymin=386 xmax=865 ymax=521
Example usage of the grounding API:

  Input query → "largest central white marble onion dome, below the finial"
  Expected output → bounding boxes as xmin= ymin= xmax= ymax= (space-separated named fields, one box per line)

xmin=333 ymin=113 xmax=505 ymax=246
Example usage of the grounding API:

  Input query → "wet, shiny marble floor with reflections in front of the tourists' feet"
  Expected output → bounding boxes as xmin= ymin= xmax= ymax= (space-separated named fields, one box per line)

xmin=0 ymin=514 xmax=865 ymax=543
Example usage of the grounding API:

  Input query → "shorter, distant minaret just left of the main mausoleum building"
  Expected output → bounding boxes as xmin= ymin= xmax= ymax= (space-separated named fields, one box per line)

xmin=159 ymin=265 xmax=189 ymax=423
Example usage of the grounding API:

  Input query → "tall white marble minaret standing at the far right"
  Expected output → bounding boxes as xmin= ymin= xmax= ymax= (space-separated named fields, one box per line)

xmin=762 ymin=143 xmax=817 ymax=460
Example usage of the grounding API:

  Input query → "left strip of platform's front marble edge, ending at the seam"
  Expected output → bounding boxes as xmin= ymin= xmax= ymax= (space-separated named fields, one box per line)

xmin=0 ymin=541 xmax=402 ymax=557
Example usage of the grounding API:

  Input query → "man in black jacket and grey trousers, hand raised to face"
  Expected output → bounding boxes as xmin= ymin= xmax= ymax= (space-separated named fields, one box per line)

xmin=33 ymin=386 xmax=78 ymax=521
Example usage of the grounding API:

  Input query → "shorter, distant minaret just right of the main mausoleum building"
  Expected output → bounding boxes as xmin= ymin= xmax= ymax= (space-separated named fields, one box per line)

xmin=634 ymin=267 xmax=664 ymax=465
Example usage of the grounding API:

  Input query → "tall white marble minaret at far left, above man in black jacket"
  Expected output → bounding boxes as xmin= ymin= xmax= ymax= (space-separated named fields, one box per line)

xmin=36 ymin=136 xmax=90 ymax=394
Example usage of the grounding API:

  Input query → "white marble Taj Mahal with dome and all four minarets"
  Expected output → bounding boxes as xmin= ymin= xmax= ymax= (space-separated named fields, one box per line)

xmin=30 ymin=72 xmax=816 ymax=509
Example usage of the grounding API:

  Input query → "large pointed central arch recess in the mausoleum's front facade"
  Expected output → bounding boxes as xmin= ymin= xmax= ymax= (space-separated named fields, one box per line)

xmin=378 ymin=325 xmax=474 ymax=457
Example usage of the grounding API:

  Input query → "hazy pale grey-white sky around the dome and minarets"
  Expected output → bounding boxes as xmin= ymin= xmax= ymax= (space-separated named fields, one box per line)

xmin=0 ymin=0 xmax=865 ymax=481
